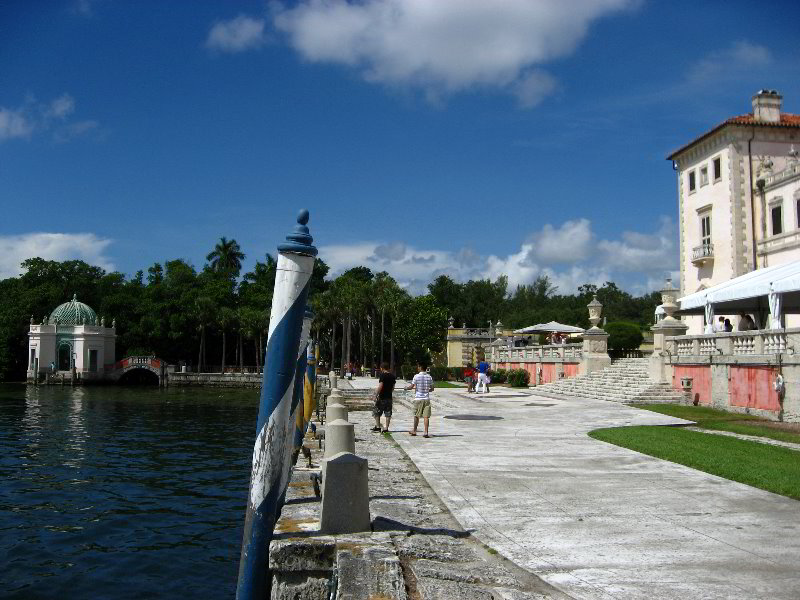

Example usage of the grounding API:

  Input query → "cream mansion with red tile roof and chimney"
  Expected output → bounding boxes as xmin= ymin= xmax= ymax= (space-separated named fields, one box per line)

xmin=668 ymin=90 xmax=800 ymax=334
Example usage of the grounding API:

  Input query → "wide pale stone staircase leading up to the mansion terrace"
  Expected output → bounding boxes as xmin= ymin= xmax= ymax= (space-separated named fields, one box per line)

xmin=531 ymin=358 xmax=686 ymax=404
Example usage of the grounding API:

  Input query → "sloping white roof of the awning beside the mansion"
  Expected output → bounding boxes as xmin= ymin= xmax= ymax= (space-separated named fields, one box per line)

xmin=678 ymin=261 xmax=800 ymax=313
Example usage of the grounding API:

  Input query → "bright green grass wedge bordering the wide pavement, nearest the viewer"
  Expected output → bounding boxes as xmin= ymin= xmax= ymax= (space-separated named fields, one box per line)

xmin=589 ymin=425 xmax=800 ymax=500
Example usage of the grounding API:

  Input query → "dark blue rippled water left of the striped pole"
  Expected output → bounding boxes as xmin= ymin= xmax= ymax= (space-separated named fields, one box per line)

xmin=0 ymin=384 xmax=258 ymax=599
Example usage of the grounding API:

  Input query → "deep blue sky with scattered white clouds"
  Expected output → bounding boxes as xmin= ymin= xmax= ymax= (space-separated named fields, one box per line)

xmin=0 ymin=0 xmax=800 ymax=292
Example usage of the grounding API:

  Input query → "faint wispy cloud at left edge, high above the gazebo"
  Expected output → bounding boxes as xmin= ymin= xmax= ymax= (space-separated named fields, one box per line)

xmin=0 ymin=94 xmax=100 ymax=142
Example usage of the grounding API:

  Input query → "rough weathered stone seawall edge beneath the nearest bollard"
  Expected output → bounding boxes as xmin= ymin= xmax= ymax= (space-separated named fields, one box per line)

xmin=270 ymin=398 xmax=569 ymax=600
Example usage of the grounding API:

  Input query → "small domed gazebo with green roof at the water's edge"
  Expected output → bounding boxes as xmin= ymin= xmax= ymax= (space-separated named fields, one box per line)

xmin=28 ymin=295 xmax=117 ymax=380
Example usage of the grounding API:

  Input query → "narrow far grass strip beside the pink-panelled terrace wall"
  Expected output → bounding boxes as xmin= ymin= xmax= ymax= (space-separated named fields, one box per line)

xmin=633 ymin=404 xmax=800 ymax=444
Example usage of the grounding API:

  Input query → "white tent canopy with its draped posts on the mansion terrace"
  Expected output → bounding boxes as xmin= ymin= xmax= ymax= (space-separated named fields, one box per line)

xmin=678 ymin=261 xmax=800 ymax=328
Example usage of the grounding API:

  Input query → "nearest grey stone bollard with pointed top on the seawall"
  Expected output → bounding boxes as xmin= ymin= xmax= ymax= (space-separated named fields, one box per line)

xmin=319 ymin=452 xmax=370 ymax=534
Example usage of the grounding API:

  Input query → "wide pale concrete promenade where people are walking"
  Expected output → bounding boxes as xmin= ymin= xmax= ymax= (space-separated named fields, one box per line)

xmin=355 ymin=382 xmax=800 ymax=600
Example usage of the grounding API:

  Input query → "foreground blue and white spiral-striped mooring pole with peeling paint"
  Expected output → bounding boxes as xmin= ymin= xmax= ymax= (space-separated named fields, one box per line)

xmin=236 ymin=210 xmax=317 ymax=600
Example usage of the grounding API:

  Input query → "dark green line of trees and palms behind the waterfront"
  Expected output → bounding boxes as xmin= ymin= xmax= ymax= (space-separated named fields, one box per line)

xmin=0 ymin=237 xmax=658 ymax=381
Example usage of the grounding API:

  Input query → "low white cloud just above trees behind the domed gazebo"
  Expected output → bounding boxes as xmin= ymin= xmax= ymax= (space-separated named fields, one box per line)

xmin=0 ymin=233 xmax=114 ymax=279
